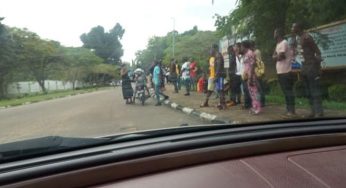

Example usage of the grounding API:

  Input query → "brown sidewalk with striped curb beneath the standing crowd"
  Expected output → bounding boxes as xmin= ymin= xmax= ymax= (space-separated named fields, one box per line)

xmin=159 ymin=85 xmax=346 ymax=124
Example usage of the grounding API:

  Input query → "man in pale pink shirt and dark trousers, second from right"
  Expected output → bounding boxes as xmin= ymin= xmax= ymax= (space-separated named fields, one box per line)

xmin=273 ymin=29 xmax=295 ymax=117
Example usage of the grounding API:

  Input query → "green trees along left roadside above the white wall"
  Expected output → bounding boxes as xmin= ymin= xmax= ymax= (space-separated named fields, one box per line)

xmin=0 ymin=23 xmax=119 ymax=99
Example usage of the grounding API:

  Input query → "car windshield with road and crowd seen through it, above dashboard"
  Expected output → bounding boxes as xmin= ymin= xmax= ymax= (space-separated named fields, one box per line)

xmin=0 ymin=0 xmax=346 ymax=159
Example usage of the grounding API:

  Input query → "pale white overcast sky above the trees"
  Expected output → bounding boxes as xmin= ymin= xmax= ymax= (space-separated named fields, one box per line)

xmin=0 ymin=0 xmax=236 ymax=62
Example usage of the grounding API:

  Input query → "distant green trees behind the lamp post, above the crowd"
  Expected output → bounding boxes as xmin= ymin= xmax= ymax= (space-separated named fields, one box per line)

xmin=136 ymin=26 xmax=218 ymax=72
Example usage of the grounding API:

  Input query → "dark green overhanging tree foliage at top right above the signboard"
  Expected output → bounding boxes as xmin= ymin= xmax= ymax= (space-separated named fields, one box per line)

xmin=215 ymin=0 xmax=346 ymax=78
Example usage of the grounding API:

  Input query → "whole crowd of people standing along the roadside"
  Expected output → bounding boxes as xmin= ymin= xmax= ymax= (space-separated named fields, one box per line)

xmin=121 ymin=23 xmax=323 ymax=117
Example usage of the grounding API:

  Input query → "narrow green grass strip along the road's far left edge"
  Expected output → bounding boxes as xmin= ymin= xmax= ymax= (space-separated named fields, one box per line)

xmin=0 ymin=87 xmax=111 ymax=107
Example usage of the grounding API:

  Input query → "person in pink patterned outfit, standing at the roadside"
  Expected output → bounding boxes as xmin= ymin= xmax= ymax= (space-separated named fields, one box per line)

xmin=241 ymin=41 xmax=262 ymax=115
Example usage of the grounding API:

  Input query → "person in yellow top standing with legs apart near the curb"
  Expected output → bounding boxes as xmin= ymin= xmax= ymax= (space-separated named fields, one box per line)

xmin=200 ymin=44 xmax=226 ymax=110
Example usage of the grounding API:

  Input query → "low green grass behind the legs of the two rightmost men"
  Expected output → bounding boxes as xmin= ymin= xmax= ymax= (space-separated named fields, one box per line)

xmin=266 ymin=95 xmax=346 ymax=111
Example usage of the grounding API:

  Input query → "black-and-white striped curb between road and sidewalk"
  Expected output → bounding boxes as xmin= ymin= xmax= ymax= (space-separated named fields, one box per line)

xmin=157 ymin=98 xmax=231 ymax=124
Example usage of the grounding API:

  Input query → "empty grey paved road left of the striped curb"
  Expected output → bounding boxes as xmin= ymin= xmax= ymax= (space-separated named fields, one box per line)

xmin=0 ymin=88 xmax=203 ymax=143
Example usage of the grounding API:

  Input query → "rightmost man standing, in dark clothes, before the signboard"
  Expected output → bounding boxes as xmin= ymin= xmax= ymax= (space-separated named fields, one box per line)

xmin=292 ymin=23 xmax=323 ymax=117
